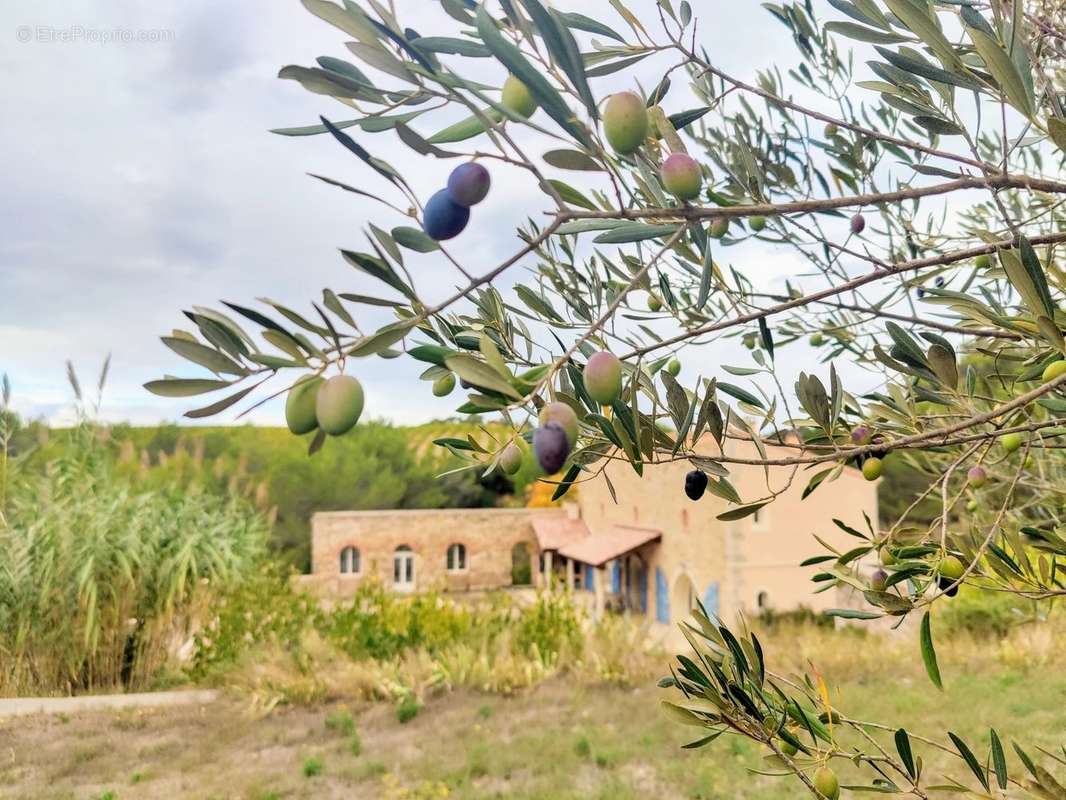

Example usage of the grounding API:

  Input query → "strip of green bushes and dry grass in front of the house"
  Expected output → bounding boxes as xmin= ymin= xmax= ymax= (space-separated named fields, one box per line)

xmin=191 ymin=571 xmax=659 ymax=710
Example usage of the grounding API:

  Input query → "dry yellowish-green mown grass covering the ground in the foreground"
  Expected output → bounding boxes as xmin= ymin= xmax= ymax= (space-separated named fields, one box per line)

xmin=0 ymin=627 xmax=1066 ymax=800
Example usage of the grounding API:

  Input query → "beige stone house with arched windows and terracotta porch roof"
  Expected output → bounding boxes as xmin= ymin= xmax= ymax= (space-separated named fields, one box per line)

xmin=307 ymin=439 xmax=877 ymax=623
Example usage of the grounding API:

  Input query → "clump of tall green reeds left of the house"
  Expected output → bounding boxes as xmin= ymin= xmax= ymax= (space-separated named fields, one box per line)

xmin=0 ymin=422 xmax=268 ymax=694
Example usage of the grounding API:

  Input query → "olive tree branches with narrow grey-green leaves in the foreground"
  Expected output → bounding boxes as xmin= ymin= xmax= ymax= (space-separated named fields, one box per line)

xmin=148 ymin=0 xmax=1066 ymax=798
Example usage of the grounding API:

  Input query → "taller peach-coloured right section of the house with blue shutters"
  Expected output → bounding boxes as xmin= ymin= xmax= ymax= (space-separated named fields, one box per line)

xmin=579 ymin=438 xmax=877 ymax=623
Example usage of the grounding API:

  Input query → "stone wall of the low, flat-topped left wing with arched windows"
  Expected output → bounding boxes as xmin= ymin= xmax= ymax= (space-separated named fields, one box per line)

xmin=311 ymin=509 xmax=565 ymax=596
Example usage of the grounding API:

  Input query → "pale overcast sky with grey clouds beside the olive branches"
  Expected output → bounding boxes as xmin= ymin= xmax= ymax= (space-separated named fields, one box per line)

xmin=0 ymin=0 xmax=882 ymax=422
